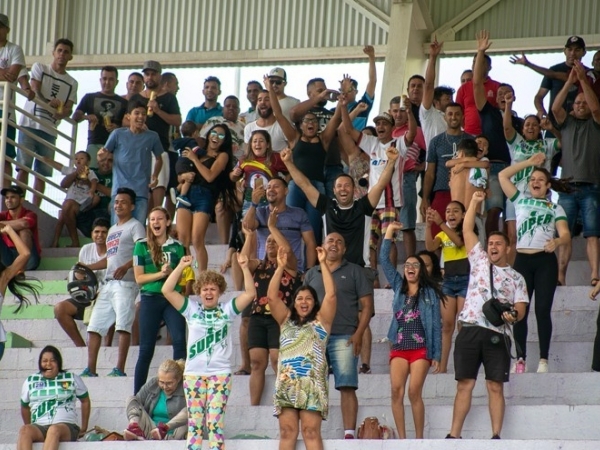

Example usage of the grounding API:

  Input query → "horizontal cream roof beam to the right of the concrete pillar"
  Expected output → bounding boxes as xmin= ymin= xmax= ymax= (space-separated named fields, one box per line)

xmin=423 ymin=34 xmax=600 ymax=55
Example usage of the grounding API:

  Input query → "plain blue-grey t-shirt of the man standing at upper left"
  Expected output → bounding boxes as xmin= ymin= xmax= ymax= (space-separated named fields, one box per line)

xmin=105 ymin=128 xmax=164 ymax=198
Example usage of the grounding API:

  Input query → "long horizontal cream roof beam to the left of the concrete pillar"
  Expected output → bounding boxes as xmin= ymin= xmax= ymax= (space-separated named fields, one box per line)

xmin=26 ymin=45 xmax=387 ymax=69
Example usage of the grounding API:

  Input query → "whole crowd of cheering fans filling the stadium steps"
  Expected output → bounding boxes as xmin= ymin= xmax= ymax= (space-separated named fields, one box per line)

xmin=0 ymin=10 xmax=600 ymax=450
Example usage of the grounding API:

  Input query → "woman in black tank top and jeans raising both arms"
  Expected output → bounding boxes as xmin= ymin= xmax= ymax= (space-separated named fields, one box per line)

xmin=264 ymin=76 xmax=342 ymax=248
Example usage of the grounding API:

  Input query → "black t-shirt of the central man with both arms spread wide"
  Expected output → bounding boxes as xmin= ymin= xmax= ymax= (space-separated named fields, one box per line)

xmin=316 ymin=194 xmax=375 ymax=267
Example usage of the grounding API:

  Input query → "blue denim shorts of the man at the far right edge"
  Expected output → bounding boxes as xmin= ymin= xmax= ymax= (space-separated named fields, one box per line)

xmin=558 ymin=184 xmax=600 ymax=237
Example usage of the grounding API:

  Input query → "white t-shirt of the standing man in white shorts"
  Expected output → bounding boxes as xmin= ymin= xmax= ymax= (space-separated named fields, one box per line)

xmin=106 ymin=217 xmax=146 ymax=281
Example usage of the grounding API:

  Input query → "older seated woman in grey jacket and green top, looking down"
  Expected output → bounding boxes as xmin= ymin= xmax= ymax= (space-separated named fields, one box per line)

xmin=123 ymin=359 xmax=187 ymax=441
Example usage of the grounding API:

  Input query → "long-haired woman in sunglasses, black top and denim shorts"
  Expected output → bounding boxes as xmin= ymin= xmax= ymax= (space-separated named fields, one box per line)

xmin=176 ymin=124 xmax=237 ymax=271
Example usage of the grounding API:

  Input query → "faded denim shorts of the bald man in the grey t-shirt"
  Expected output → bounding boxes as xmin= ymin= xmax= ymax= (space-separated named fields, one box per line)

xmin=327 ymin=334 xmax=358 ymax=390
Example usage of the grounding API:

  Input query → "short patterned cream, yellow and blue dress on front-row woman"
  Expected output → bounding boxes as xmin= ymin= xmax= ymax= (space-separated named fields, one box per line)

xmin=274 ymin=320 xmax=329 ymax=420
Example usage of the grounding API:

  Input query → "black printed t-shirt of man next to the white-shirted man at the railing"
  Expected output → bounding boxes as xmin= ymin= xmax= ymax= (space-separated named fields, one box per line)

xmin=77 ymin=92 xmax=127 ymax=145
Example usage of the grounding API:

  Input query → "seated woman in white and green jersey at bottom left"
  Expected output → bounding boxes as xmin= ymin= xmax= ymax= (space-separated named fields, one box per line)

xmin=17 ymin=345 xmax=91 ymax=450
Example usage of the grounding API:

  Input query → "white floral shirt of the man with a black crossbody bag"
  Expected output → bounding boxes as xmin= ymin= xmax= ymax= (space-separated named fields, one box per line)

xmin=458 ymin=242 xmax=529 ymax=333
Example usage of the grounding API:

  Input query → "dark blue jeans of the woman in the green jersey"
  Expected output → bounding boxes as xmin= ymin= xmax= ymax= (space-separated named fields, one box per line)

xmin=133 ymin=293 xmax=186 ymax=394
